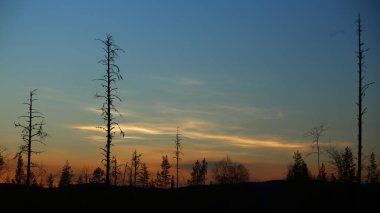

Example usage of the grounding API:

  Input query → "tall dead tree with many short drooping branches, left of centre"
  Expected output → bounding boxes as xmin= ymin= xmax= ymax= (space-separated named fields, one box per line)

xmin=95 ymin=34 xmax=124 ymax=185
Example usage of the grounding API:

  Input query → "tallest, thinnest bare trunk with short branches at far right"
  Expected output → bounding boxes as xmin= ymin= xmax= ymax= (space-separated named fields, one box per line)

xmin=357 ymin=14 xmax=374 ymax=183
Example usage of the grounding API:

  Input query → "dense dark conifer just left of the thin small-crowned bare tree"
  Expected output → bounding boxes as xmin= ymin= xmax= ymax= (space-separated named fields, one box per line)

xmin=286 ymin=150 xmax=310 ymax=181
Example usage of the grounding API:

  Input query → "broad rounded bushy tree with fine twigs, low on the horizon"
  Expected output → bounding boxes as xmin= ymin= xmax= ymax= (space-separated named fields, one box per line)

xmin=213 ymin=156 xmax=249 ymax=184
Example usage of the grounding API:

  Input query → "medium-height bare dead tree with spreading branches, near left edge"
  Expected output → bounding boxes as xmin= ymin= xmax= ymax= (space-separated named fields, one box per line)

xmin=14 ymin=90 xmax=47 ymax=186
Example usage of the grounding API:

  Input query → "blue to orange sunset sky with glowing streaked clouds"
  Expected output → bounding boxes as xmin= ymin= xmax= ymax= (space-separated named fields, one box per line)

xmin=0 ymin=0 xmax=380 ymax=183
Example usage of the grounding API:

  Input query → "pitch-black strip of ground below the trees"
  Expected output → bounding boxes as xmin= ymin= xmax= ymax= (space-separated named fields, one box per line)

xmin=0 ymin=181 xmax=380 ymax=213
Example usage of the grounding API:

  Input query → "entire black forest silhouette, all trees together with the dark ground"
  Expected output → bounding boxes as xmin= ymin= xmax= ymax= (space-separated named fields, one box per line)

xmin=0 ymin=15 xmax=380 ymax=212
